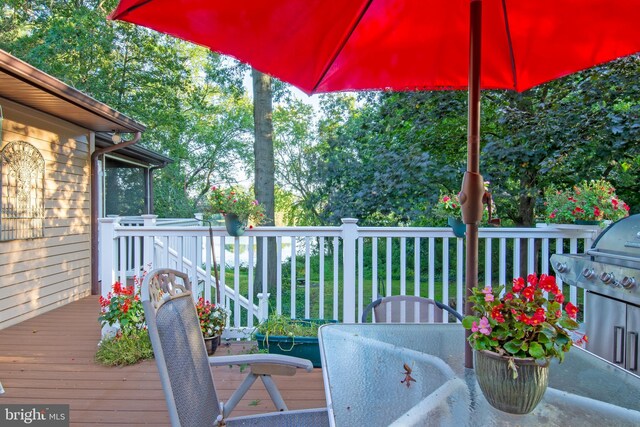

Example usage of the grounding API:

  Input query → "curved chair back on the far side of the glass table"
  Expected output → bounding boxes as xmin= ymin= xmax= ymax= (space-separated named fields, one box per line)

xmin=362 ymin=295 xmax=462 ymax=323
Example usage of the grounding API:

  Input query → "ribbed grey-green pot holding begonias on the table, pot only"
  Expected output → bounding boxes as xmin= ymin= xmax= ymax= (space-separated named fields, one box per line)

xmin=474 ymin=350 xmax=549 ymax=414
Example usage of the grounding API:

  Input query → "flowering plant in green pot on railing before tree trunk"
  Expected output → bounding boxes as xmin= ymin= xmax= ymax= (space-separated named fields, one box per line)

xmin=208 ymin=186 xmax=265 ymax=236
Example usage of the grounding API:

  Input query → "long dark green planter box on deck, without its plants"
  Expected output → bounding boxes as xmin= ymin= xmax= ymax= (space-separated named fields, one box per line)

xmin=255 ymin=319 xmax=337 ymax=368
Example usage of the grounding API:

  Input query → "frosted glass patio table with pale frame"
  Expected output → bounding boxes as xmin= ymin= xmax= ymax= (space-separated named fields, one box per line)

xmin=319 ymin=324 xmax=640 ymax=427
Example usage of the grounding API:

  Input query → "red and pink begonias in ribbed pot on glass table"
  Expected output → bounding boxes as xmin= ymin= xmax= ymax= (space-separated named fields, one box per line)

xmin=462 ymin=274 xmax=587 ymax=414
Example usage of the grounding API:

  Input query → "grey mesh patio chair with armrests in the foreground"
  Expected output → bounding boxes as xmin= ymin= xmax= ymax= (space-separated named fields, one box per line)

xmin=141 ymin=268 xmax=329 ymax=427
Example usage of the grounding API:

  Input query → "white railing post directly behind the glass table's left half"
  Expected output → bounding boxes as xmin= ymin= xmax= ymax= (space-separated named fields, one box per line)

xmin=341 ymin=218 xmax=358 ymax=323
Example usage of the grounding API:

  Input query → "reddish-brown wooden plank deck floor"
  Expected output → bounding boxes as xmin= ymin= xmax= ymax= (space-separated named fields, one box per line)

xmin=0 ymin=296 xmax=326 ymax=426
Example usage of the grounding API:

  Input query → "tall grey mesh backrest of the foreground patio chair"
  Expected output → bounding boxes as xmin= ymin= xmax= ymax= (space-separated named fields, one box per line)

xmin=141 ymin=268 xmax=220 ymax=426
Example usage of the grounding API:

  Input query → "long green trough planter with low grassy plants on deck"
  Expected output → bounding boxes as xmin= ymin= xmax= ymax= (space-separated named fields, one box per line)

xmin=254 ymin=314 xmax=336 ymax=368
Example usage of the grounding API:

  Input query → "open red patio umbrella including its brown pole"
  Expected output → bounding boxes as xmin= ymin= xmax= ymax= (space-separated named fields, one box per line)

xmin=110 ymin=0 xmax=640 ymax=367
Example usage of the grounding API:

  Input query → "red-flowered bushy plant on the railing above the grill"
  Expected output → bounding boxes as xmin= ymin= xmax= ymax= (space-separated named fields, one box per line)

xmin=544 ymin=179 xmax=629 ymax=224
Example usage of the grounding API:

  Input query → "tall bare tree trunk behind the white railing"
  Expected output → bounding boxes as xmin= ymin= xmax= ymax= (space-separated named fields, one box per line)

xmin=253 ymin=69 xmax=276 ymax=294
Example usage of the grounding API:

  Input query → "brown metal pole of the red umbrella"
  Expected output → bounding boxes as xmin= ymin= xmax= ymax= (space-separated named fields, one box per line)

xmin=461 ymin=0 xmax=484 ymax=368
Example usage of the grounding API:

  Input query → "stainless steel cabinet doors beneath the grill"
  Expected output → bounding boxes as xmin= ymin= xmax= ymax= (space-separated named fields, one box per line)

xmin=585 ymin=291 xmax=640 ymax=374
